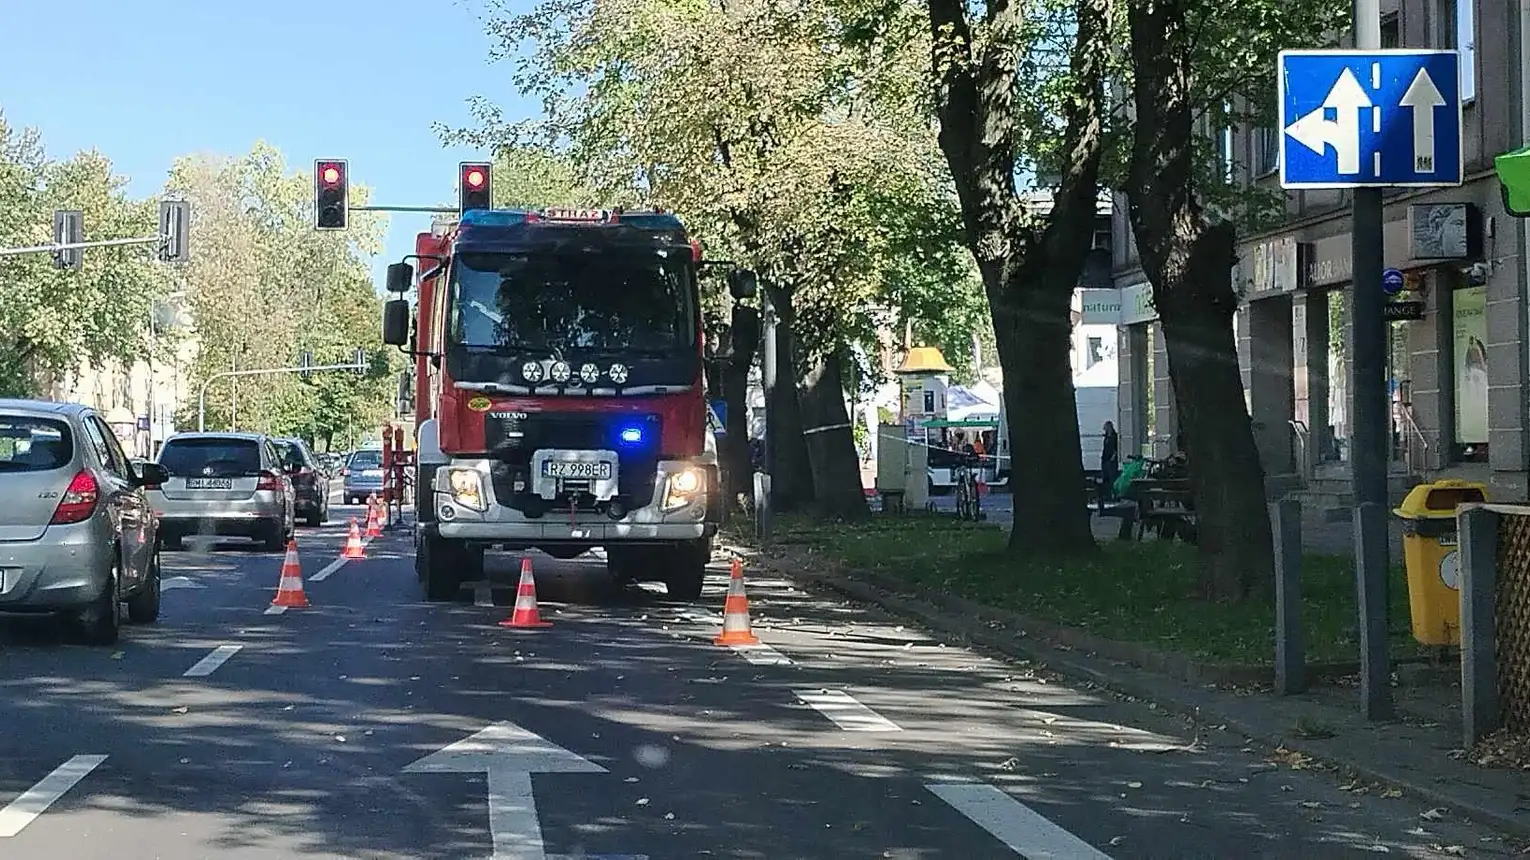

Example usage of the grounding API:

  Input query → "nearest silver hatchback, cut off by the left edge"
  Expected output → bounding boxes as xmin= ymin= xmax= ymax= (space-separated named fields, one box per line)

xmin=0 ymin=399 xmax=165 ymax=644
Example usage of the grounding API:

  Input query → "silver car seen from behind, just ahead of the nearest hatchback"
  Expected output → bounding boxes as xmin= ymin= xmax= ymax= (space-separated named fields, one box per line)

xmin=148 ymin=433 xmax=297 ymax=551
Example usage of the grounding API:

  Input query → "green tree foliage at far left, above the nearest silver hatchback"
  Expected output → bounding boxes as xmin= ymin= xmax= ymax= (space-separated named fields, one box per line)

xmin=0 ymin=115 xmax=165 ymax=395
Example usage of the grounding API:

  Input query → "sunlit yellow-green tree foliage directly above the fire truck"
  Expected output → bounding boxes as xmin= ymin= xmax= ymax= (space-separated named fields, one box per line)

xmin=447 ymin=0 xmax=979 ymax=373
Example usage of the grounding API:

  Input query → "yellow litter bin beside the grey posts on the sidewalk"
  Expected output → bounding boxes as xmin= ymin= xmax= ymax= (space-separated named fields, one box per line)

xmin=1392 ymin=479 xmax=1487 ymax=646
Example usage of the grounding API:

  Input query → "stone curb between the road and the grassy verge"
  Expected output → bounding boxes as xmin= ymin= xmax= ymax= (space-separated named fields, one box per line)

xmin=756 ymin=552 xmax=1530 ymax=840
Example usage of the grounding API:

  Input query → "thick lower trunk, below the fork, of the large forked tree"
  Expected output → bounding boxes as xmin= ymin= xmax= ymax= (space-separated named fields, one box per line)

xmin=990 ymin=266 xmax=1094 ymax=555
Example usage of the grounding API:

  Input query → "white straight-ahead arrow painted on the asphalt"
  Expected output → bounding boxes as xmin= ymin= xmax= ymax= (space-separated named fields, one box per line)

xmin=404 ymin=722 xmax=609 ymax=860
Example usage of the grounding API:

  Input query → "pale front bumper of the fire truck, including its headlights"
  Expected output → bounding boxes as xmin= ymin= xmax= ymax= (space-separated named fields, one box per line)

xmin=433 ymin=461 xmax=721 ymax=545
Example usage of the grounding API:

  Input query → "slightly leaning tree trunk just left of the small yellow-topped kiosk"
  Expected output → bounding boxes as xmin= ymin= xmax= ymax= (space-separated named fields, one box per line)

xmin=802 ymin=350 xmax=871 ymax=520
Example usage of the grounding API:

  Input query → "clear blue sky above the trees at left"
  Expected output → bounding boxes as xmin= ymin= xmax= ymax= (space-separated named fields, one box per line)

xmin=0 ymin=0 xmax=536 ymax=284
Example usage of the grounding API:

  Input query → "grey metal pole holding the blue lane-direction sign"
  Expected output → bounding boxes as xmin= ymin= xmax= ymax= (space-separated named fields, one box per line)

xmin=1349 ymin=0 xmax=1392 ymax=719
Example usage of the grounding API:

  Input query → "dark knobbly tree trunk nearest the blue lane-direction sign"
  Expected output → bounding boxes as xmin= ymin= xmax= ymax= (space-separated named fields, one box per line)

xmin=1126 ymin=0 xmax=1274 ymax=600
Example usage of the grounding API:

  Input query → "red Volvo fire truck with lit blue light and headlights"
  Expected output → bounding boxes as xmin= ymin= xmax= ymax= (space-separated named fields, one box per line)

xmin=383 ymin=164 xmax=756 ymax=600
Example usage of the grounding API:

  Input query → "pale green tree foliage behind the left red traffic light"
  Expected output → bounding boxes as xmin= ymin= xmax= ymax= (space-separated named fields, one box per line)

xmin=167 ymin=144 xmax=401 ymax=444
